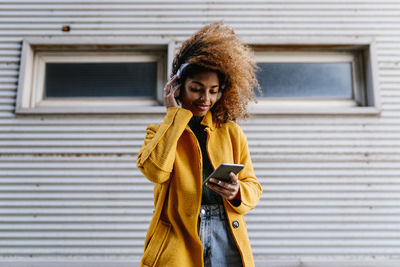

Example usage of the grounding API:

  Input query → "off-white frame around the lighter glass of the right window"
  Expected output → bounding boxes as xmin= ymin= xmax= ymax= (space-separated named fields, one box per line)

xmin=243 ymin=37 xmax=381 ymax=115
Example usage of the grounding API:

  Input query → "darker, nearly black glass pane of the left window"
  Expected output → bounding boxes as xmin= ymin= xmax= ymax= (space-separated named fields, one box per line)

xmin=45 ymin=62 xmax=157 ymax=98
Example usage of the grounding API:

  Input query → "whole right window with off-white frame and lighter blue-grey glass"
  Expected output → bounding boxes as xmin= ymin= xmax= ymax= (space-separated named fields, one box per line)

xmin=252 ymin=40 xmax=379 ymax=114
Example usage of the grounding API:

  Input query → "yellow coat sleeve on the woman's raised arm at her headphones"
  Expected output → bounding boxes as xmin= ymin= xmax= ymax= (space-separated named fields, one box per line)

xmin=136 ymin=107 xmax=193 ymax=183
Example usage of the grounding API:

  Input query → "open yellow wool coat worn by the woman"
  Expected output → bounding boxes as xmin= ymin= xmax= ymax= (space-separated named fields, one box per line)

xmin=137 ymin=107 xmax=262 ymax=267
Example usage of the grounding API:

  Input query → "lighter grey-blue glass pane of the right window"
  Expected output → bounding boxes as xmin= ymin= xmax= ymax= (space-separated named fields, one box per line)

xmin=257 ymin=62 xmax=353 ymax=99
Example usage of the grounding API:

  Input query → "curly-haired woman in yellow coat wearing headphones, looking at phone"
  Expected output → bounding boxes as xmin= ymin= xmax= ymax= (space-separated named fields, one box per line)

xmin=137 ymin=22 xmax=262 ymax=267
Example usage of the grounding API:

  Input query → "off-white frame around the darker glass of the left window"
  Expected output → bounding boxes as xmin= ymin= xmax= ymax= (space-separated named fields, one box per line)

xmin=15 ymin=38 xmax=176 ymax=114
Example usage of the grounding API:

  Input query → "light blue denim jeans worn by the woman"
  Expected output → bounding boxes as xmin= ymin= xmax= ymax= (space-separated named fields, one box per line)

xmin=199 ymin=204 xmax=243 ymax=267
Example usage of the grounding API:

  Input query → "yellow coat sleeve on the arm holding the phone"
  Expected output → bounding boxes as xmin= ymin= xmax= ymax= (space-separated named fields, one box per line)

xmin=228 ymin=126 xmax=262 ymax=215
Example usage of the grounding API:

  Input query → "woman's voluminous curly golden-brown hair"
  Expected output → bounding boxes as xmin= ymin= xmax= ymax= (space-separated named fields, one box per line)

xmin=171 ymin=21 xmax=260 ymax=124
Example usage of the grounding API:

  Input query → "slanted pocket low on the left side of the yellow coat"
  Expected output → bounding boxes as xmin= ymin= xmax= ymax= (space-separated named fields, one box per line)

xmin=142 ymin=220 xmax=171 ymax=267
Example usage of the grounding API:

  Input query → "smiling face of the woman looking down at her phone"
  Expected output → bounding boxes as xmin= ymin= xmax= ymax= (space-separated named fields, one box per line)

xmin=181 ymin=71 xmax=219 ymax=116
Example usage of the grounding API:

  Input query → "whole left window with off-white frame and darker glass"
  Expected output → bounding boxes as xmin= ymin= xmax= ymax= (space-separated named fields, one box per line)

xmin=16 ymin=40 xmax=171 ymax=114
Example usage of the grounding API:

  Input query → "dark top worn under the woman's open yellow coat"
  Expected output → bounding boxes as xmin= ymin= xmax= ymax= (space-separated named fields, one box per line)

xmin=189 ymin=116 xmax=222 ymax=204
